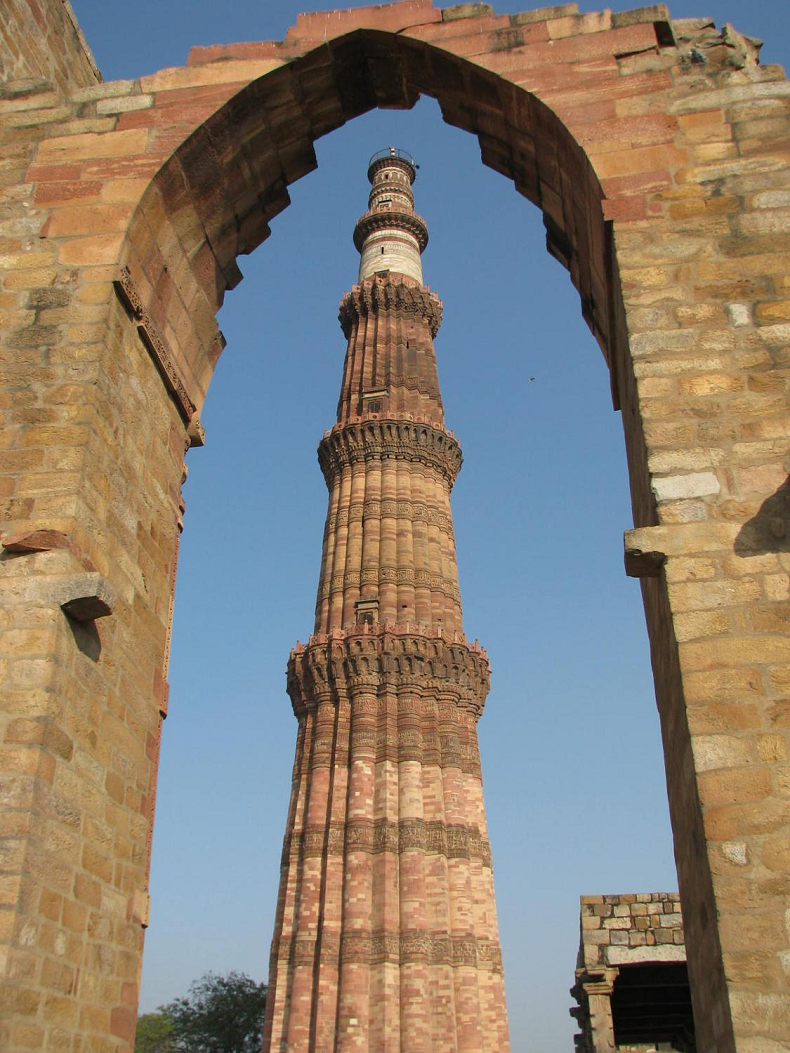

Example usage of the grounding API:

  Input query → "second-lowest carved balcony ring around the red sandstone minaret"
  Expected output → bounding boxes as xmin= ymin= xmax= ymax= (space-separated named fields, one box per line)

xmin=318 ymin=420 xmax=463 ymax=489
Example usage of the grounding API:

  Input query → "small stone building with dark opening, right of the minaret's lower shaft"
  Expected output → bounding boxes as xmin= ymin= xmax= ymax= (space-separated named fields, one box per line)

xmin=570 ymin=892 xmax=696 ymax=1053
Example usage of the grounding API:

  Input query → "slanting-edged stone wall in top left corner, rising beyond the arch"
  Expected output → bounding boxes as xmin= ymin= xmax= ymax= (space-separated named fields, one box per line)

xmin=0 ymin=0 xmax=101 ymax=100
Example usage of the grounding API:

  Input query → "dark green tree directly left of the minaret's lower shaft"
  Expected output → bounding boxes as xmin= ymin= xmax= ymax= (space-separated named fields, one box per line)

xmin=159 ymin=972 xmax=266 ymax=1053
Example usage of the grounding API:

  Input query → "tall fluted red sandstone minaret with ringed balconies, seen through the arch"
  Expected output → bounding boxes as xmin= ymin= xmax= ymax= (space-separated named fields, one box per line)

xmin=263 ymin=147 xmax=510 ymax=1053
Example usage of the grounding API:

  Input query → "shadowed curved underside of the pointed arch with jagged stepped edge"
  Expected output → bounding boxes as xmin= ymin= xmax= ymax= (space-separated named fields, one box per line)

xmin=134 ymin=29 xmax=614 ymax=419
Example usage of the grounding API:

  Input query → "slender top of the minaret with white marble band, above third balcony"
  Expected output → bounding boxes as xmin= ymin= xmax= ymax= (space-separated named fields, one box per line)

xmin=354 ymin=146 xmax=428 ymax=285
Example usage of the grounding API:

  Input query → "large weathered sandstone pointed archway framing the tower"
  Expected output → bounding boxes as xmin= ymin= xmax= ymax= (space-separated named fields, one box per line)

xmin=0 ymin=0 xmax=790 ymax=1051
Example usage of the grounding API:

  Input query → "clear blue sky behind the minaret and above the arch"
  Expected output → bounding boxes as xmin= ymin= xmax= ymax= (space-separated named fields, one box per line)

xmin=73 ymin=0 xmax=788 ymax=1053
